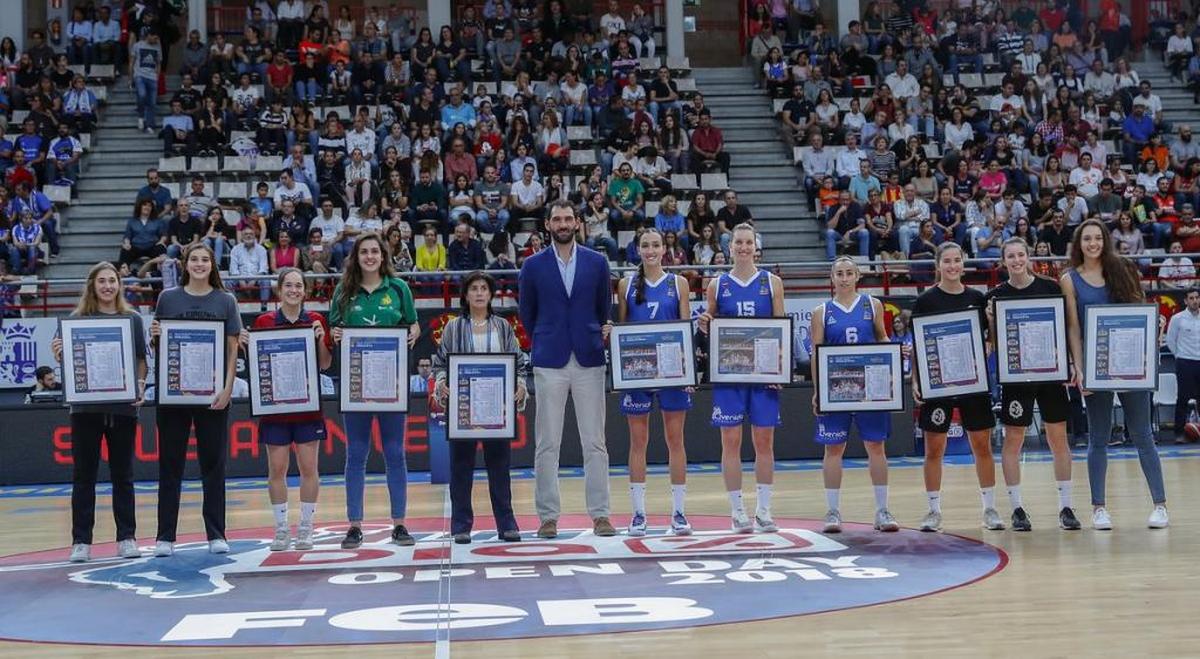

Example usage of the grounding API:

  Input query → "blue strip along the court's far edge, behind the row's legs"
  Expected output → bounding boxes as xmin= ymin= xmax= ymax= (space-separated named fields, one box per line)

xmin=0 ymin=445 xmax=1200 ymax=505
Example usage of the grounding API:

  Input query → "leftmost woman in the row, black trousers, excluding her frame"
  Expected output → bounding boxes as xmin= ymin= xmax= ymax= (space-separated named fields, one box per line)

xmin=50 ymin=262 xmax=146 ymax=563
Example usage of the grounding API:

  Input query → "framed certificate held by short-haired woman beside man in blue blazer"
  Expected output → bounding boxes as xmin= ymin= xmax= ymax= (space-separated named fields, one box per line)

xmin=446 ymin=353 xmax=517 ymax=441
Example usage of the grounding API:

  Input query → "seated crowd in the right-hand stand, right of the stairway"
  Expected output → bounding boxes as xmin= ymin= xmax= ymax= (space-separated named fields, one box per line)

xmin=750 ymin=0 xmax=1200 ymax=279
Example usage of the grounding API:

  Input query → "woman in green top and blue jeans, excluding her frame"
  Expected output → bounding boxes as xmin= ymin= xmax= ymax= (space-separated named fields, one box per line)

xmin=329 ymin=232 xmax=421 ymax=549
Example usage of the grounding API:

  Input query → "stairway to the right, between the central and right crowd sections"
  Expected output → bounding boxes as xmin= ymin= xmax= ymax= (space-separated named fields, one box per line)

xmin=692 ymin=67 xmax=824 ymax=263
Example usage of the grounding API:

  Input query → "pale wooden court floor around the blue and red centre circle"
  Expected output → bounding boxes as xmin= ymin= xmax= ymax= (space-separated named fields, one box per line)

xmin=0 ymin=456 xmax=1200 ymax=659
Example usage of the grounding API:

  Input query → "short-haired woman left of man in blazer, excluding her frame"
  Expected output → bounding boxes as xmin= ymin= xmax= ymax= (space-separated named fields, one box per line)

xmin=433 ymin=270 xmax=529 ymax=545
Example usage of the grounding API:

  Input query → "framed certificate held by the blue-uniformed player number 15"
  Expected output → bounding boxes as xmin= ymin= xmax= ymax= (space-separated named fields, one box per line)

xmin=708 ymin=316 xmax=792 ymax=384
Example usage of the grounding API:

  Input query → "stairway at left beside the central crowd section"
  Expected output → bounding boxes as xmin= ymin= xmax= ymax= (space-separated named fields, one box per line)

xmin=51 ymin=77 xmax=166 ymax=278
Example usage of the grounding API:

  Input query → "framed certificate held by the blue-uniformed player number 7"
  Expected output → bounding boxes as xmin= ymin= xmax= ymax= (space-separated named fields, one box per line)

xmin=608 ymin=320 xmax=696 ymax=391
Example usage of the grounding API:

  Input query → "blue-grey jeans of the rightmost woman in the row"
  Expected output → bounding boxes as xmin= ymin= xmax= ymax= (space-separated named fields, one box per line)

xmin=1084 ymin=391 xmax=1166 ymax=505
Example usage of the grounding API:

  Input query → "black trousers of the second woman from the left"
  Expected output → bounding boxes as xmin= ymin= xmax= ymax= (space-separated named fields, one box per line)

xmin=157 ymin=407 xmax=229 ymax=543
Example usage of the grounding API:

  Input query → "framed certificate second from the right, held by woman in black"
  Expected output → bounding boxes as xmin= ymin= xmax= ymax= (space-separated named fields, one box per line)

xmin=995 ymin=295 xmax=1069 ymax=384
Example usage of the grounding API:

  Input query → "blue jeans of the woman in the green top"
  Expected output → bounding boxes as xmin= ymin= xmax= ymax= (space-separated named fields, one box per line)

xmin=342 ymin=412 xmax=408 ymax=522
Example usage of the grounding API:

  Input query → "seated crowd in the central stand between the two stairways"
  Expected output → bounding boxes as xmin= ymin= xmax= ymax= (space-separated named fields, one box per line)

xmin=108 ymin=0 xmax=752 ymax=303
